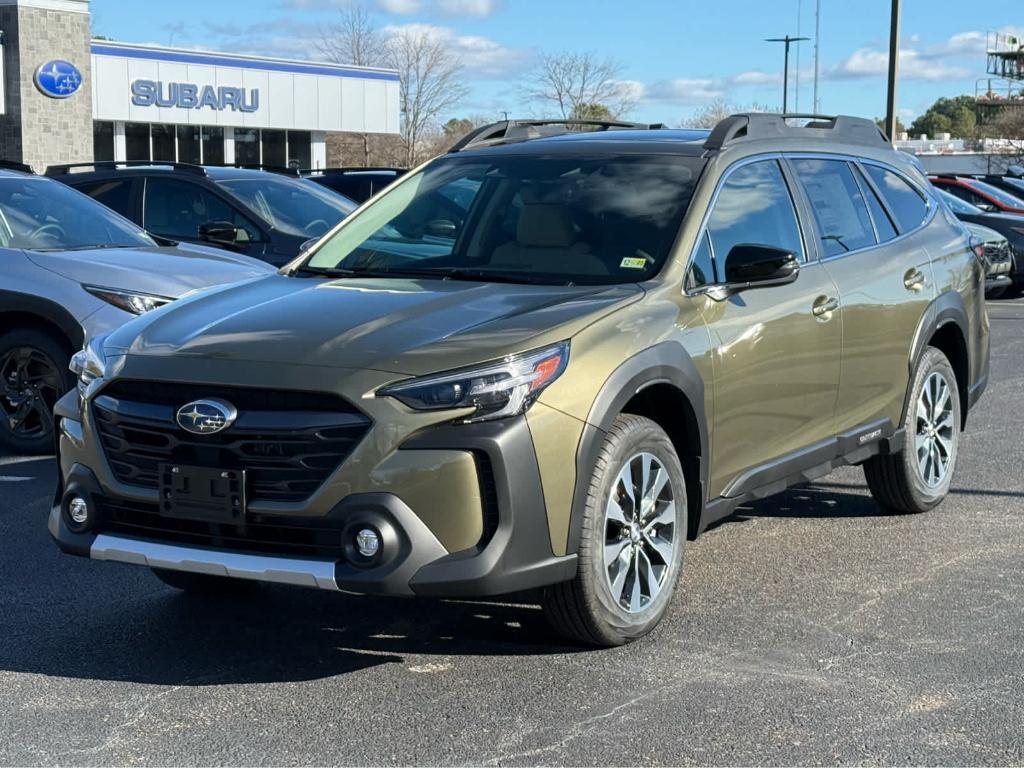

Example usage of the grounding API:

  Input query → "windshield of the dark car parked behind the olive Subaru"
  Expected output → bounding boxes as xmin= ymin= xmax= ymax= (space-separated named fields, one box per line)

xmin=219 ymin=174 xmax=355 ymax=238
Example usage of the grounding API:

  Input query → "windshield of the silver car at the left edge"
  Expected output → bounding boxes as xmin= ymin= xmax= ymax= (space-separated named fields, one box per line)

xmin=0 ymin=177 xmax=156 ymax=251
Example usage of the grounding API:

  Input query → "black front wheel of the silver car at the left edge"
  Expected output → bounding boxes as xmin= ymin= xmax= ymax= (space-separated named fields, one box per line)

xmin=0 ymin=328 xmax=75 ymax=454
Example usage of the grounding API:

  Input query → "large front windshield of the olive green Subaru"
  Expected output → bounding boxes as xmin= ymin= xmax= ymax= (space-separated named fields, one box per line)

xmin=304 ymin=154 xmax=703 ymax=285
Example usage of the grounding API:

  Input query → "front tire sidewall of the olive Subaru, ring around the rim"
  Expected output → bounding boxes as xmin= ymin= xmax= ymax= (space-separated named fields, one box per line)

xmin=580 ymin=417 xmax=687 ymax=641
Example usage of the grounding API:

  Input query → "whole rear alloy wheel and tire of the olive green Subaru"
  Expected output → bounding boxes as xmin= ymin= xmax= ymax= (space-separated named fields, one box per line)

xmin=864 ymin=347 xmax=962 ymax=512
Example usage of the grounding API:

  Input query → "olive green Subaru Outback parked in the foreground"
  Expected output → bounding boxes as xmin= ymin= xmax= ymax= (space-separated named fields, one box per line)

xmin=49 ymin=114 xmax=988 ymax=645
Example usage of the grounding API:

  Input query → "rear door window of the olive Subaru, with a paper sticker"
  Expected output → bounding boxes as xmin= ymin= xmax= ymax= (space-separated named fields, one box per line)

xmin=793 ymin=158 xmax=874 ymax=256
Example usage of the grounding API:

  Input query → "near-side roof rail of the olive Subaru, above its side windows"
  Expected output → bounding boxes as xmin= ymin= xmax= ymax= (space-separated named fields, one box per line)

xmin=705 ymin=113 xmax=892 ymax=151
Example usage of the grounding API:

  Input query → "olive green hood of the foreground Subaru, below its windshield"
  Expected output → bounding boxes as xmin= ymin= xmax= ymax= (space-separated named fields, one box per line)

xmin=105 ymin=274 xmax=643 ymax=375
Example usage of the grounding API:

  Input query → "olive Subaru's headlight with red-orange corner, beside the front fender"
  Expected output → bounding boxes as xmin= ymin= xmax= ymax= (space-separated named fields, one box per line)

xmin=379 ymin=341 xmax=569 ymax=423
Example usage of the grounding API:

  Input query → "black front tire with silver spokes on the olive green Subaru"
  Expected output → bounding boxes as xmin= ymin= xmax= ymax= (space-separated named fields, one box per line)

xmin=543 ymin=415 xmax=687 ymax=646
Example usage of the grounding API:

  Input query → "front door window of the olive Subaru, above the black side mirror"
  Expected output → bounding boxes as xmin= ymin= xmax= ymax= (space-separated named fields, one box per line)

xmin=698 ymin=160 xmax=804 ymax=273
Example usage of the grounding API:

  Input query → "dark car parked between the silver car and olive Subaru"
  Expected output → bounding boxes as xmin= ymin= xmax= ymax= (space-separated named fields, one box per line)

xmin=46 ymin=163 xmax=355 ymax=266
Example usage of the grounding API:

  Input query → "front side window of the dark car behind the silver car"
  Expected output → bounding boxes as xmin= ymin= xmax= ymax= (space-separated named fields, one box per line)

xmin=142 ymin=177 xmax=260 ymax=241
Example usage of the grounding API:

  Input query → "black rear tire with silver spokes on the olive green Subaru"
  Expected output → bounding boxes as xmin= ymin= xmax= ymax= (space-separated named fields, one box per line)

xmin=864 ymin=347 xmax=962 ymax=512
